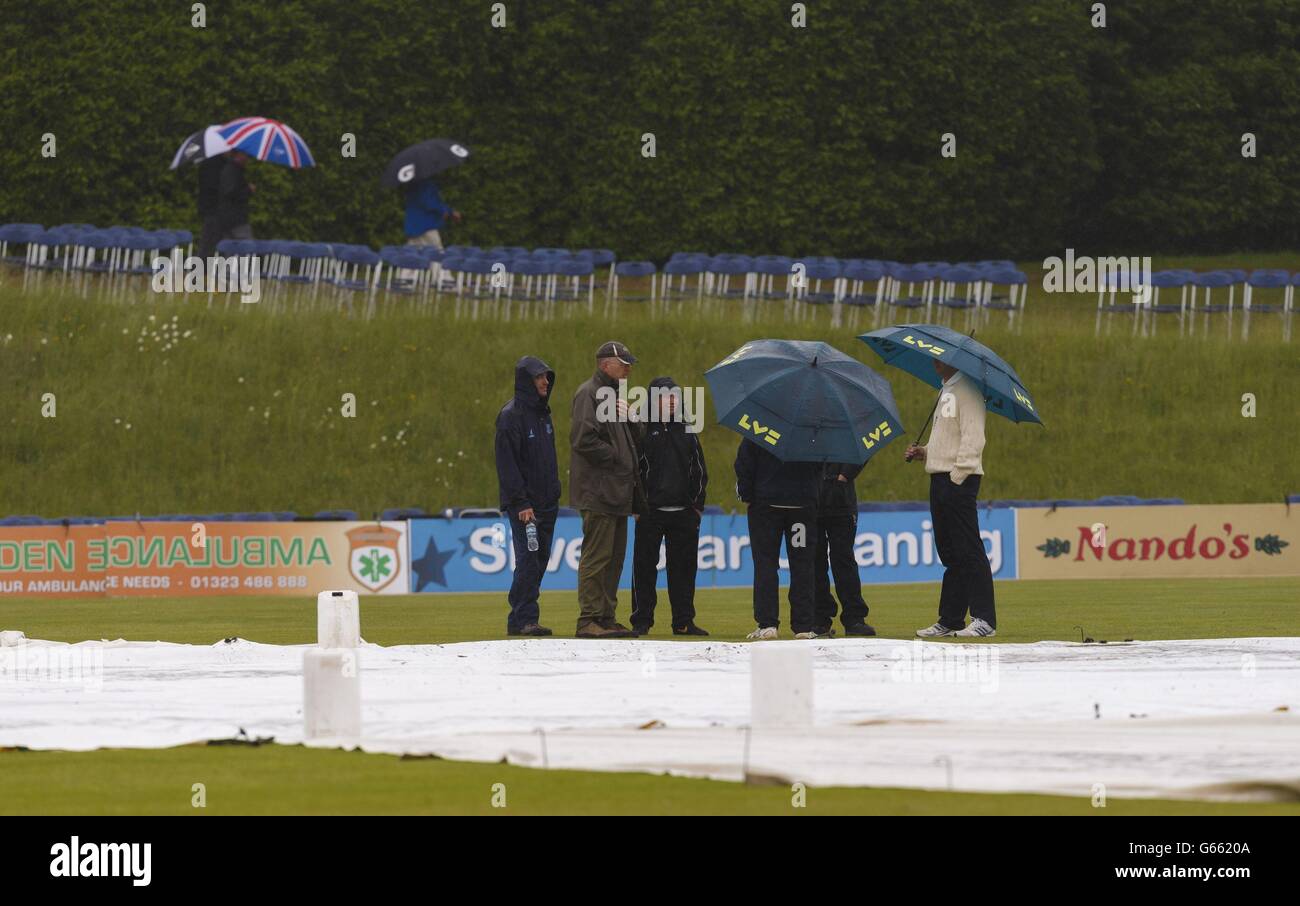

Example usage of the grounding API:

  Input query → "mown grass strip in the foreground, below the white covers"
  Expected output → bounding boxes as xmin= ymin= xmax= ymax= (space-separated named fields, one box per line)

xmin=0 ymin=745 xmax=1300 ymax=815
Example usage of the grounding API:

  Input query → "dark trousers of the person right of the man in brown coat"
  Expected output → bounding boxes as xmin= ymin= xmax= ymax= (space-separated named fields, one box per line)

xmin=632 ymin=507 xmax=699 ymax=629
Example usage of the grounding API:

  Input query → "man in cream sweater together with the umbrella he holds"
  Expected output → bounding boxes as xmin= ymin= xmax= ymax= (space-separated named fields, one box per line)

xmin=858 ymin=324 xmax=1043 ymax=638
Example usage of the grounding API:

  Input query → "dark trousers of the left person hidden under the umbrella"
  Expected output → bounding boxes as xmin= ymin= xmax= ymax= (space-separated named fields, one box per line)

xmin=749 ymin=503 xmax=816 ymax=633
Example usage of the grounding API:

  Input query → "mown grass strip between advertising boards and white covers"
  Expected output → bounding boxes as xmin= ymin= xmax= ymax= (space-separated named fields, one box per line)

xmin=0 ymin=578 xmax=1300 ymax=645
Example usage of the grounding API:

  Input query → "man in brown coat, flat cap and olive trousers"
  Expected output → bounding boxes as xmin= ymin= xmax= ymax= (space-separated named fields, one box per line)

xmin=569 ymin=341 xmax=645 ymax=638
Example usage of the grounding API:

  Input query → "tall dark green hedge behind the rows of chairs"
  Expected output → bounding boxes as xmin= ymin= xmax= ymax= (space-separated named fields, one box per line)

xmin=0 ymin=0 xmax=1300 ymax=260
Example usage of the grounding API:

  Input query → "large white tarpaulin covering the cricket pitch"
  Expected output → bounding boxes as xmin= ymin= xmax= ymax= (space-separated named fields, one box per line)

xmin=0 ymin=634 xmax=1300 ymax=798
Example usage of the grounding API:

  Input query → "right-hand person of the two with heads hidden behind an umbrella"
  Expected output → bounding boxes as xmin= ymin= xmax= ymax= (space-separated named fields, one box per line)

xmin=815 ymin=463 xmax=876 ymax=637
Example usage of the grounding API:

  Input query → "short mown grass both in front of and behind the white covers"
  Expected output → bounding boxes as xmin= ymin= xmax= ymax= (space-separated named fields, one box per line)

xmin=0 ymin=578 xmax=1300 ymax=815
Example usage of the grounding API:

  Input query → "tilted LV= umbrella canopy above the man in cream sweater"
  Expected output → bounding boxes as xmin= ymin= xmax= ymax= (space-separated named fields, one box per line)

xmin=858 ymin=324 xmax=1043 ymax=425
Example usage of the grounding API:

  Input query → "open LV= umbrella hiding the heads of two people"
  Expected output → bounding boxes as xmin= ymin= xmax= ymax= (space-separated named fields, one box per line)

xmin=705 ymin=339 xmax=902 ymax=464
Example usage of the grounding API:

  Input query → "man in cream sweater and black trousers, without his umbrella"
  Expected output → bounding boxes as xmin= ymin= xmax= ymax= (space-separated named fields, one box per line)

xmin=906 ymin=360 xmax=997 ymax=638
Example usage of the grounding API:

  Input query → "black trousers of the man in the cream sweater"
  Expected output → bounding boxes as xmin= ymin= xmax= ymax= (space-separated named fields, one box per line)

xmin=930 ymin=473 xmax=997 ymax=629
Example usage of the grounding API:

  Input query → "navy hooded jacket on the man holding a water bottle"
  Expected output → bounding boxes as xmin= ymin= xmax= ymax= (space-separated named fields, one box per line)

xmin=497 ymin=355 xmax=560 ymax=516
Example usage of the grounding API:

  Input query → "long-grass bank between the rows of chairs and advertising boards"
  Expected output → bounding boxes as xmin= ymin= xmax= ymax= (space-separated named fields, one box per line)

xmin=0 ymin=255 xmax=1300 ymax=517
